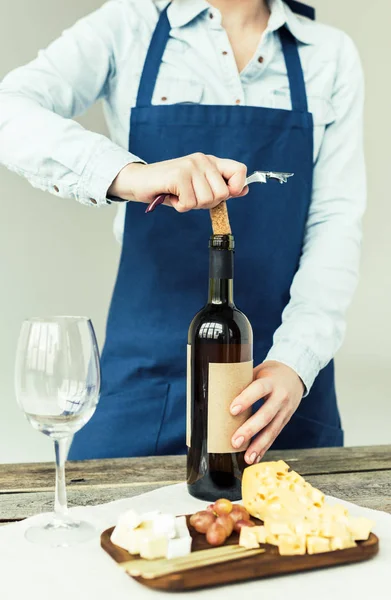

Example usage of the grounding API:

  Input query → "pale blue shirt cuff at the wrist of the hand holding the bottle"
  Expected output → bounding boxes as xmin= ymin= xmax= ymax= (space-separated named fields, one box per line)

xmin=265 ymin=339 xmax=321 ymax=397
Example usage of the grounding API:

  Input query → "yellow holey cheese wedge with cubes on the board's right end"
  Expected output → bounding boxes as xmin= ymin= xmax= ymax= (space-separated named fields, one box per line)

xmin=242 ymin=461 xmax=374 ymax=555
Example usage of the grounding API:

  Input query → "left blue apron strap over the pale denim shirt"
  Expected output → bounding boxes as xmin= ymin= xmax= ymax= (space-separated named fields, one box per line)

xmin=136 ymin=6 xmax=171 ymax=106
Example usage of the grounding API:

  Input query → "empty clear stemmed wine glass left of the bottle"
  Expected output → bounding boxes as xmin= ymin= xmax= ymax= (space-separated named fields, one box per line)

xmin=15 ymin=317 xmax=100 ymax=546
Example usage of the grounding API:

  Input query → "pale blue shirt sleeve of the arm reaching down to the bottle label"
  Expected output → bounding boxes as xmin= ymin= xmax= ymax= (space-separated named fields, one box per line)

xmin=267 ymin=34 xmax=366 ymax=394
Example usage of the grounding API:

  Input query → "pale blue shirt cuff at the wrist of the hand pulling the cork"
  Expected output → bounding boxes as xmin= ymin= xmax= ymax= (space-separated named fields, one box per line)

xmin=77 ymin=142 xmax=144 ymax=206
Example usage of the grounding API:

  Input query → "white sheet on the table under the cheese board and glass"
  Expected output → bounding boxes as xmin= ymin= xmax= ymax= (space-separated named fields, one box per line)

xmin=0 ymin=484 xmax=391 ymax=600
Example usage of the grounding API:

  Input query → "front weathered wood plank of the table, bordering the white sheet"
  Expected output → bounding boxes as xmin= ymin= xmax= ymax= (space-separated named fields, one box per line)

xmin=0 ymin=470 xmax=391 ymax=519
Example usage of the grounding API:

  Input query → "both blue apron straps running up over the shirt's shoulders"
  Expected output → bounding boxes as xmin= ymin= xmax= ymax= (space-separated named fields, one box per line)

xmin=136 ymin=7 xmax=308 ymax=112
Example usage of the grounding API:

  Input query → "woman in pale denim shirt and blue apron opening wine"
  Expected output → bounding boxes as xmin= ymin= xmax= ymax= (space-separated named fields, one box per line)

xmin=0 ymin=0 xmax=365 ymax=464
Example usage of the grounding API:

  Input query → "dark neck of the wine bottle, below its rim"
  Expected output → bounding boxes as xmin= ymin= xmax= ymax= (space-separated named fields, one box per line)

xmin=208 ymin=248 xmax=234 ymax=306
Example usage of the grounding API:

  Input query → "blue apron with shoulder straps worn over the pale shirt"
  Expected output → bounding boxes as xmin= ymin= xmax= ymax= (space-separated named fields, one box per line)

xmin=70 ymin=2 xmax=343 ymax=459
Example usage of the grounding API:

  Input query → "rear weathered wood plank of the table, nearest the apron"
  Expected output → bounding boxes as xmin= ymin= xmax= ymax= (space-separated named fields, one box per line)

xmin=0 ymin=446 xmax=391 ymax=495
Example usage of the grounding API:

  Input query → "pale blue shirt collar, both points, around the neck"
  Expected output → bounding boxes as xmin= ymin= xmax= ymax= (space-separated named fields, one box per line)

xmin=167 ymin=0 xmax=315 ymax=44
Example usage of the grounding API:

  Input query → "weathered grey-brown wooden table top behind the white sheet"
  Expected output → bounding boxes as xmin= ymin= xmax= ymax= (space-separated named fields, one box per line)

xmin=0 ymin=446 xmax=391 ymax=524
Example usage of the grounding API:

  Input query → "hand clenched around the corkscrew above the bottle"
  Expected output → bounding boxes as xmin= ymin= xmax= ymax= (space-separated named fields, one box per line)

xmin=108 ymin=153 xmax=248 ymax=213
